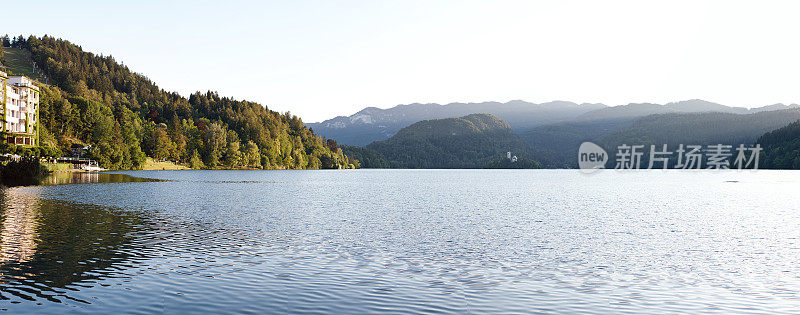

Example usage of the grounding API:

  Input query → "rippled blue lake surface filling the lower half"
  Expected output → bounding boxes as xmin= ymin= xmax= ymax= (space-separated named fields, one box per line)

xmin=0 ymin=170 xmax=800 ymax=314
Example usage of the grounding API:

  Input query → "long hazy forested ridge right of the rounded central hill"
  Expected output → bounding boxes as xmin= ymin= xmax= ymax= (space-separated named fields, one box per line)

xmin=522 ymin=109 xmax=800 ymax=168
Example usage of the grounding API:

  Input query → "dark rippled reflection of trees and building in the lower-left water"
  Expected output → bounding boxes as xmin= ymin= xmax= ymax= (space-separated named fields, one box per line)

xmin=0 ymin=192 xmax=146 ymax=303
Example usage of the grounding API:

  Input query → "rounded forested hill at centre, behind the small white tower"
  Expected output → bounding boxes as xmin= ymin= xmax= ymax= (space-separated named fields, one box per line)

xmin=362 ymin=114 xmax=538 ymax=168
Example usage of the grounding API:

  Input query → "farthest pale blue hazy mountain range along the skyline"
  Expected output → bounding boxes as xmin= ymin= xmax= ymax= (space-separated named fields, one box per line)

xmin=306 ymin=100 xmax=800 ymax=146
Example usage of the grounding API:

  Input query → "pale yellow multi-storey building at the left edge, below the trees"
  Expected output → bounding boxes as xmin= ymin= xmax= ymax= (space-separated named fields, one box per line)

xmin=0 ymin=71 xmax=39 ymax=146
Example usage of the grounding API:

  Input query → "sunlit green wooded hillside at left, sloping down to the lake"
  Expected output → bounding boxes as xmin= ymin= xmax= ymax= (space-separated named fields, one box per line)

xmin=2 ymin=36 xmax=358 ymax=169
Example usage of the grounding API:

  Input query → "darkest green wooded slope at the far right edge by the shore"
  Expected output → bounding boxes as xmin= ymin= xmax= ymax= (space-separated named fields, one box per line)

xmin=757 ymin=121 xmax=800 ymax=170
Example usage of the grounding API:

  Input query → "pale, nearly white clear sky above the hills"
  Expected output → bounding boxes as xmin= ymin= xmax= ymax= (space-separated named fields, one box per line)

xmin=6 ymin=0 xmax=800 ymax=122
